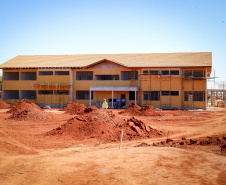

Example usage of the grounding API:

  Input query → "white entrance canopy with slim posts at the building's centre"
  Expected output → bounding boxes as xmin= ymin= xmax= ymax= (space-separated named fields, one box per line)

xmin=89 ymin=87 xmax=138 ymax=108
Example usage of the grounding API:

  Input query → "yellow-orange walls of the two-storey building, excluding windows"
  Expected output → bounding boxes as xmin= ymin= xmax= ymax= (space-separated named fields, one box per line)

xmin=3 ymin=65 xmax=211 ymax=108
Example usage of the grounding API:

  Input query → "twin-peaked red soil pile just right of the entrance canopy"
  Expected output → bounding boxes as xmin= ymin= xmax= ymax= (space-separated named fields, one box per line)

xmin=119 ymin=103 xmax=160 ymax=116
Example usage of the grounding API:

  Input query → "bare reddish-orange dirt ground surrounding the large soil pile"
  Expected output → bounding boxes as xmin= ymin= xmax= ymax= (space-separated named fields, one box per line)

xmin=0 ymin=105 xmax=226 ymax=185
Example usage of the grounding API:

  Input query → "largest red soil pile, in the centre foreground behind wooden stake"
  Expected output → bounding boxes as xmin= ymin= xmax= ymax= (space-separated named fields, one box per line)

xmin=46 ymin=109 xmax=162 ymax=142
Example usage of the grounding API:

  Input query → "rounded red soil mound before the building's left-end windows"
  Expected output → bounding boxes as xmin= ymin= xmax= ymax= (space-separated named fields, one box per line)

xmin=8 ymin=100 xmax=50 ymax=121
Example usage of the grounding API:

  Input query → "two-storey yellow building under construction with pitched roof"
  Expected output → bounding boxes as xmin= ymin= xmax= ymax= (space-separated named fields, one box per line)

xmin=0 ymin=52 xmax=212 ymax=109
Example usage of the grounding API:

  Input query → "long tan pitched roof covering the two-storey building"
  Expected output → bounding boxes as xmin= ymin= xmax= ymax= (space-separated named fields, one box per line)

xmin=0 ymin=52 xmax=212 ymax=69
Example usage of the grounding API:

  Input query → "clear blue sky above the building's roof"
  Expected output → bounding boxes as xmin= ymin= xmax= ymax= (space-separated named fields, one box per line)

xmin=0 ymin=0 xmax=226 ymax=86
